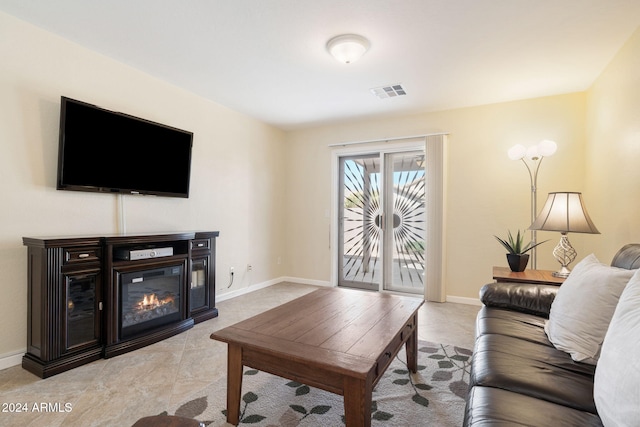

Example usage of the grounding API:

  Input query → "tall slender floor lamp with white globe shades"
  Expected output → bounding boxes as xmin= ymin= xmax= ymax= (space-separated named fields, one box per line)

xmin=507 ymin=139 xmax=558 ymax=270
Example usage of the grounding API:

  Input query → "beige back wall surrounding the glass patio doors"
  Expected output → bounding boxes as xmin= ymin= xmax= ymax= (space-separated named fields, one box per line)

xmin=286 ymin=93 xmax=599 ymax=298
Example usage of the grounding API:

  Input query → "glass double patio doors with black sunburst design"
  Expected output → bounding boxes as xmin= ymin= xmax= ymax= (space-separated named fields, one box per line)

xmin=337 ymin=148 xmax=425 ymax=294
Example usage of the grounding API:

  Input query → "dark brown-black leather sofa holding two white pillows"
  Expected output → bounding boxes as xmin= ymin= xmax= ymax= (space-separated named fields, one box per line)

xmin=464 ymin=244 xmax=640 ymax=427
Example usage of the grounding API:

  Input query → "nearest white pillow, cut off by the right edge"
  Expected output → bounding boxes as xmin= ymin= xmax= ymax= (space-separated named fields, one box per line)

xmin=593 ymin=270 xmax=640 ymax=427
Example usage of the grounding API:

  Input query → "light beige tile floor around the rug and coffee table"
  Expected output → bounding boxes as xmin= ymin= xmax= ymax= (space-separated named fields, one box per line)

xmin=0 ymin=283 xmax=479 ymax=427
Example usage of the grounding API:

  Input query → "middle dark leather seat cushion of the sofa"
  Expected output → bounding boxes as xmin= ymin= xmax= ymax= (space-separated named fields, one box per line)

xmin=470 ymin=334 xmax=596 ymax=413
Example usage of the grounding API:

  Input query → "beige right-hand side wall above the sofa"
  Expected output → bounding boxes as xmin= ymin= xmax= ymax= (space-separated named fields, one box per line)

xmin=585 ymin=28 xmax=640 ymax=261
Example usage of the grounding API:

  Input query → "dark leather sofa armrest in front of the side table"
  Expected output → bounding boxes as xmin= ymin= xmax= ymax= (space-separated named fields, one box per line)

xmin=480 ymin=282 xmax=560 ymax=318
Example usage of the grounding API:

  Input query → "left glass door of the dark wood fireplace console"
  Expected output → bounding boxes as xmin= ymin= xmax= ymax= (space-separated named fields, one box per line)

xmin=62 ymin=269 xmax=100 ymax=352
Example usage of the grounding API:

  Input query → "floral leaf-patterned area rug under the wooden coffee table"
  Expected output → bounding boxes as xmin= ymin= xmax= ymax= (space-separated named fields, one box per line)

xmin=164 ymin=341 xmax=472 ymax=427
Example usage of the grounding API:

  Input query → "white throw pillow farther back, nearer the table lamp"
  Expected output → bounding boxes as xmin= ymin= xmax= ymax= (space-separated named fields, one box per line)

xmin=544 ymin=254 xmax=635 ymax=365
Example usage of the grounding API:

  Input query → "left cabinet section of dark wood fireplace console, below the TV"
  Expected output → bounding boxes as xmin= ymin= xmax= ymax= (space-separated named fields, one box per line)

xmin=22 ymin=237 xmax=104 ymax=378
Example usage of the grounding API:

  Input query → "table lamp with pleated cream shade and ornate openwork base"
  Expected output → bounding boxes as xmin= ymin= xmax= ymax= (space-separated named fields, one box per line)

xmin=529 ymin=192 xmax=600 ymax=277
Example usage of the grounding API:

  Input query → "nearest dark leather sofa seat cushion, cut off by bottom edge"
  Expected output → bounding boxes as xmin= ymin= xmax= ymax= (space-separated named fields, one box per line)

xmin=464 ymin=387 xmax=602 ymax=427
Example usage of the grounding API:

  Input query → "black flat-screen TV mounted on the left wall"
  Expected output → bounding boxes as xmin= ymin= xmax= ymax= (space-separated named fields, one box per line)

xmin=56 ymin=96 xmax=193 ymax=198
